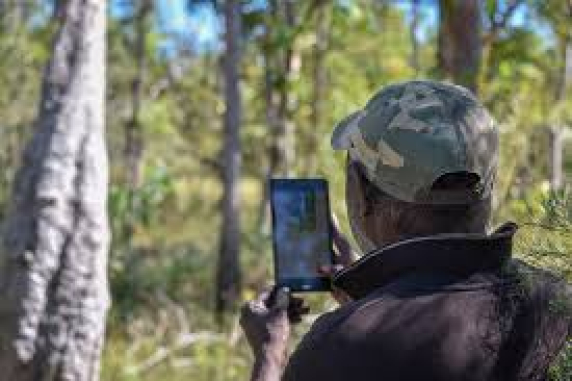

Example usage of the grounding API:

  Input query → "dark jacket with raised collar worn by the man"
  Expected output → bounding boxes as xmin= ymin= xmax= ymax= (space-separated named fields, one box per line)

xmin=283 ymin=224 xmax=572 ymax=381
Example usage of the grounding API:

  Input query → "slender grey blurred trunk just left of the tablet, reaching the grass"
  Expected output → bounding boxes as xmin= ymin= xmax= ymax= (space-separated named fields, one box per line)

xmin=216 ymin=0 xmax=242 ymax=316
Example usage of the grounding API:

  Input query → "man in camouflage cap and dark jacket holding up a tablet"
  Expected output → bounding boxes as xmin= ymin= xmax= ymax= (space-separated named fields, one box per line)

xmin=242 ymin=81 xmax=572 ymax=381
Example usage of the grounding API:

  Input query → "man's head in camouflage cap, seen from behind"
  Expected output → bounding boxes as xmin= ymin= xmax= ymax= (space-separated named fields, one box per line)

xmin=332 ymin=81 xmax=498 ymax=251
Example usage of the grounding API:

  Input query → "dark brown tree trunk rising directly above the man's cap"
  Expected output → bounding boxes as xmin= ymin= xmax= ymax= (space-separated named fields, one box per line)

xmin=438 ymin=0 xmax=482 ymax=92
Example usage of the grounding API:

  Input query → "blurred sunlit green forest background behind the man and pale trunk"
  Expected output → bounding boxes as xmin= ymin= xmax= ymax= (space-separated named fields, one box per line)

xmin=0 ymin=0 xmax=572 ymax=381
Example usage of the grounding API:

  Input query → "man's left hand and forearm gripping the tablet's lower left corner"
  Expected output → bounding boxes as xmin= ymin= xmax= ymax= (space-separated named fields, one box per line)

xmin=240 ymin=288 xmax=308 ymax=381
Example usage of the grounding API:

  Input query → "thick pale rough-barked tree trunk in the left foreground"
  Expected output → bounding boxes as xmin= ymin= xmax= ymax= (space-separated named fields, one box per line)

xmin=0 ymin=0 xmax=109 ymax=381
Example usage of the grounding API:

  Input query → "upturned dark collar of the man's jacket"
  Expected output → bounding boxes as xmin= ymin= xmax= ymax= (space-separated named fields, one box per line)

xmin=333 ymin=222 xmax=517 ymax=299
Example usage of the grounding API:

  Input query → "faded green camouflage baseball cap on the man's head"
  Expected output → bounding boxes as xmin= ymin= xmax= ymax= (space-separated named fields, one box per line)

xmin=332 ymin=81 xmax=498 ymax=204
